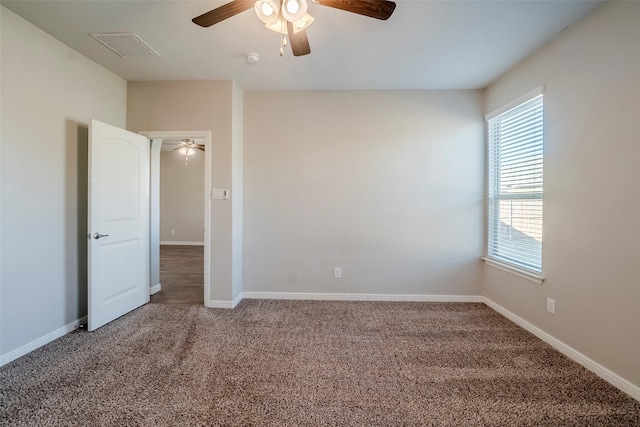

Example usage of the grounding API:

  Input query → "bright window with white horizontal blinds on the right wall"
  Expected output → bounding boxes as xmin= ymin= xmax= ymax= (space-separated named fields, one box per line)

xmin=487 ymin=91 xmax=543 ymax=275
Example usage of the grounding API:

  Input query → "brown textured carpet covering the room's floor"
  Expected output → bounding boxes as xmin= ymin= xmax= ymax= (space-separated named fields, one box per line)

xmin=0 ymin=300 xmax=640 ymax=426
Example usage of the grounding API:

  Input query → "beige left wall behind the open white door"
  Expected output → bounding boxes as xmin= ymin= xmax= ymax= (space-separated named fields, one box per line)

xmin=0 ymin=7 xmax=127 ymax=358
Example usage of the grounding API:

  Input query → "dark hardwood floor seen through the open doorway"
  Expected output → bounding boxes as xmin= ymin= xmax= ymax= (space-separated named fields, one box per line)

xmin=151 ymin=245 xmax=204 ymax=305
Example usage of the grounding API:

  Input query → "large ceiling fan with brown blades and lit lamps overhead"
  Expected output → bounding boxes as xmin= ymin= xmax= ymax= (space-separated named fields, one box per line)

xmin=192 ymin=0 xmax=396 ymax=56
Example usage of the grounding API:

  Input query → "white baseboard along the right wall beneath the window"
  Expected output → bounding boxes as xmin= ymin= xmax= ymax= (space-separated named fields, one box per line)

xmin=483 ymin=297 xmax=640 ymax=401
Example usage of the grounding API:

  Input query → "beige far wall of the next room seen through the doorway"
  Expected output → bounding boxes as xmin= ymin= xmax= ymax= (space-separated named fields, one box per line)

xmin=160 ymin=151 xmax=205 ymax=243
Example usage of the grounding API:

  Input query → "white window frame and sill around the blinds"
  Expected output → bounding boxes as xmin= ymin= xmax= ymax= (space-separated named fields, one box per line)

xmin=482 ymin=86 xmax=544 ymax=283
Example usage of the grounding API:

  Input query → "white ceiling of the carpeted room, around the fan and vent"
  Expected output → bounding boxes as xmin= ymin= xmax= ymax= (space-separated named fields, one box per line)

xmin=1 ymin=0 xmax=603 ymax=90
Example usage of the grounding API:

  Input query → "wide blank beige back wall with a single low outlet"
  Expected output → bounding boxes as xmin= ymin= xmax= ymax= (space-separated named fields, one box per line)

xmin=244 ymin=91 xmax=484 ymax=295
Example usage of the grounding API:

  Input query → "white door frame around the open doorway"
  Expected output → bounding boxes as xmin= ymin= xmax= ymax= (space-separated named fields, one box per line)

xmin=138 ymin=131 xmax=213 ymax=306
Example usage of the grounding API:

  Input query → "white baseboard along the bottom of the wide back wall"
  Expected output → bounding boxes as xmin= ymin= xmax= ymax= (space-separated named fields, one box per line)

xmin=242 ymin=292 xmax=484 ymax=302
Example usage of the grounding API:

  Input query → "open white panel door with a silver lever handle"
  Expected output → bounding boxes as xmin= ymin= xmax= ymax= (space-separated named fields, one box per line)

xmin=87 ymin=120 xmax=150 ymax=331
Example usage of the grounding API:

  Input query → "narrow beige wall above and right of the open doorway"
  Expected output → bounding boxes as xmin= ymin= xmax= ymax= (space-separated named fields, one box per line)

xmin=127 ymin=81 xmax=242 ymax=306
